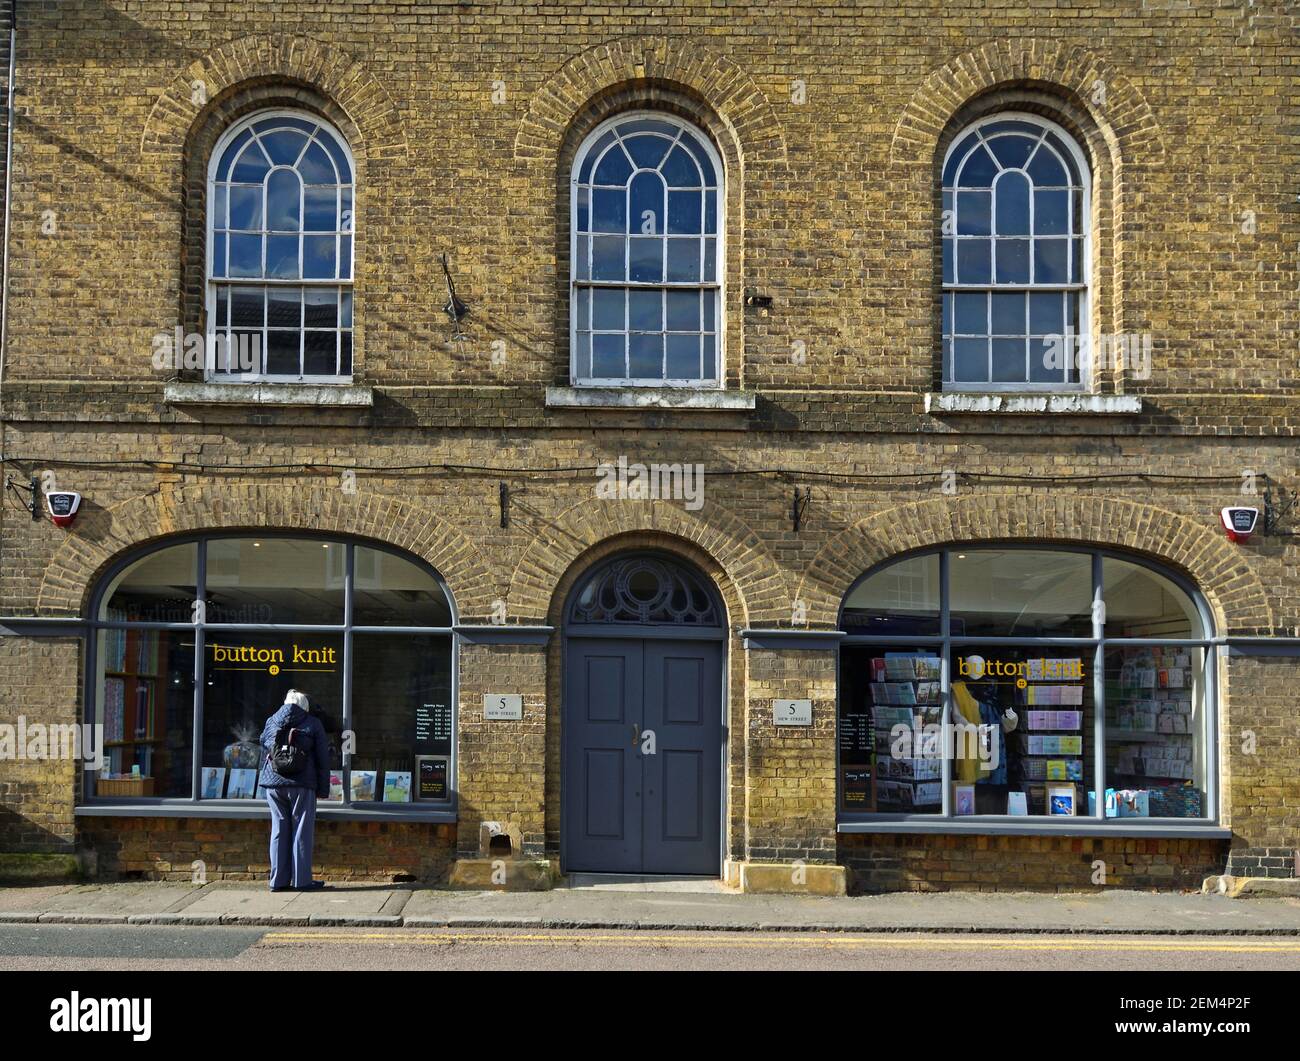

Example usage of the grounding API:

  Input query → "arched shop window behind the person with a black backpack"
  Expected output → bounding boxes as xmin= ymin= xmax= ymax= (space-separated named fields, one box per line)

xmin=87 ymin=534 xmax=455 ymax=813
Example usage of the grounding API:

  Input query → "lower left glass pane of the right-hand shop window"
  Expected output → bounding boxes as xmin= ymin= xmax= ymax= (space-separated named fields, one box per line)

xmin=839 ymin=645 xmax=944 ymax=814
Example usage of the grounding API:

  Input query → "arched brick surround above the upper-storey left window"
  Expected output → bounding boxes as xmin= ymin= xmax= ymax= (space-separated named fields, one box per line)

xmin=140 ymin=34 xmax=407 ymax=159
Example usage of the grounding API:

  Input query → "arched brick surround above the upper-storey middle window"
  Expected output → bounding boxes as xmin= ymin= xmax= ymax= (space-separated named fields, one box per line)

xmin=515 ymin=36 xmax=785 ymax=166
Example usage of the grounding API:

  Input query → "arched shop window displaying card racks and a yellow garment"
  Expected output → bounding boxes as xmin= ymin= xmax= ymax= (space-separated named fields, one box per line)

xmin=839 ymin=545 xmax=1217 ymax=831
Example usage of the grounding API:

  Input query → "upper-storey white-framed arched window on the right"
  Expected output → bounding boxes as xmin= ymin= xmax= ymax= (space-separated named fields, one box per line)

xmin=943 ymin=114 xmax=1088 ymax=390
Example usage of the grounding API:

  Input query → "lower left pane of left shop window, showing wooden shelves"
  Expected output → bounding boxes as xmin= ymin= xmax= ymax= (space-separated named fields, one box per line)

xmin=94 ymin=629 xmax=194 ymax=798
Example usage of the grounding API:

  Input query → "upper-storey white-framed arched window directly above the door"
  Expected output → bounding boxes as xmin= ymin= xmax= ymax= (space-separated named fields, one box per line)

xmin=569 ymin=112 xmax=723 ymax=386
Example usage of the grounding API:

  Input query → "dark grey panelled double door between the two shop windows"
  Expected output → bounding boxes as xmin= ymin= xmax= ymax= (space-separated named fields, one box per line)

xmin=562 ymin=637 xmax=723 ymax=875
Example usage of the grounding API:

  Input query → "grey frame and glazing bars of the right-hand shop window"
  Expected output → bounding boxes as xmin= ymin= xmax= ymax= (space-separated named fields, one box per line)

xmin=835 ymin=541 xmax=1231 ymax=837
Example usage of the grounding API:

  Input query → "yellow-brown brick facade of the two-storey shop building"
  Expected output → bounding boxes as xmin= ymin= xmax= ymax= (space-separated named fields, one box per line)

xmin=0 ymin=0 xmax=1300 ymax=889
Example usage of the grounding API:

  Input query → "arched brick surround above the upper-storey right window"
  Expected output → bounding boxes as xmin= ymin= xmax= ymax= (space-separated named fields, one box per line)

xmin=889 ymin=38 xmax=1165 ymax=168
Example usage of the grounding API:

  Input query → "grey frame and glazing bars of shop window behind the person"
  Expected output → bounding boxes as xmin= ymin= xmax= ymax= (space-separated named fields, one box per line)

xmin=75 ymin=531 xmax=460 ymax=823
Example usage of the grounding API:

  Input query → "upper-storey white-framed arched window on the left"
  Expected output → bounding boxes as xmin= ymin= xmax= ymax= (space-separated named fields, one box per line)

xmin=207 ymin=111 xmax=354 ymax=382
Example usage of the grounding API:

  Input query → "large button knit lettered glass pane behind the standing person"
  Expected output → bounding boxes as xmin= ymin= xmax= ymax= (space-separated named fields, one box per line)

xmin=199 ymin=631 xmax=343 ymax=800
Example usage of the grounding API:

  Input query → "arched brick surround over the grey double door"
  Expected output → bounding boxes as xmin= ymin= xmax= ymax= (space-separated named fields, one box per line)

xmin=507 ymin=501 xmax=790 ymax=625
